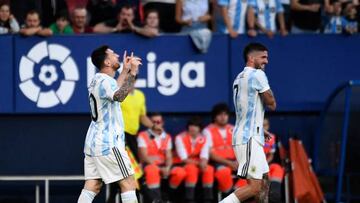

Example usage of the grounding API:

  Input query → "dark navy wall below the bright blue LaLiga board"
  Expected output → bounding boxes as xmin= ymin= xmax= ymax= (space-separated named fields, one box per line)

xmin=0 ymin=113 xmax=318 ymax=175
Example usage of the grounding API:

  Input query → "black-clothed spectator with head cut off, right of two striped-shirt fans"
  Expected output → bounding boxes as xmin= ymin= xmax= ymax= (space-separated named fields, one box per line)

xmin=291 ymin=0 xmax=321 ymax=34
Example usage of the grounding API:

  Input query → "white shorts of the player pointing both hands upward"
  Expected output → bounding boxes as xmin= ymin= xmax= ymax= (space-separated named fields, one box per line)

xmin=84 ymin=147 xmax=134 ymax=184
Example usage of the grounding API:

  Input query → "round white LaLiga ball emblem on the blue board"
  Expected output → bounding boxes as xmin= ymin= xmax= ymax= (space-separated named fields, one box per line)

xmin=19 ymin=41 xmax=79 ymax=108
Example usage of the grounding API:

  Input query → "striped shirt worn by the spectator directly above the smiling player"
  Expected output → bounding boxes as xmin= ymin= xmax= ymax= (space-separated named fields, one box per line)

xmin=249 ymin=0 xmax=284 ymax=32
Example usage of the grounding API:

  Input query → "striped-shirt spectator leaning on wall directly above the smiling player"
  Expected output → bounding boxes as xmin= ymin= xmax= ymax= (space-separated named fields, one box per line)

xmin=250 ymin=0 xmax=288 ymax=38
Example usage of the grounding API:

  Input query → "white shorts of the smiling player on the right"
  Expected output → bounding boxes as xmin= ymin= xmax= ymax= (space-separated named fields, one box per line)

xmin=233 ymin=138 xmax=269 ymax=179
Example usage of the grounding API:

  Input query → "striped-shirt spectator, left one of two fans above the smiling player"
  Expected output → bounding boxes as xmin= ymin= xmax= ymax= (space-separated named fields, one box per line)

xmin=215 ymin=0 xmax=257 ymax=38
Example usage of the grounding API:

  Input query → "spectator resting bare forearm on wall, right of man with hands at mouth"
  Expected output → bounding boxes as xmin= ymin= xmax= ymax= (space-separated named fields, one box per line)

xmin=129 ymin=10 xmax=160 ymax=37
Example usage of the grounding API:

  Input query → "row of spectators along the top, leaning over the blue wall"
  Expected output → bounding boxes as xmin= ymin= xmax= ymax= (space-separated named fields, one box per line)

xmin=0 ymin=0 xmax=360 ymax=38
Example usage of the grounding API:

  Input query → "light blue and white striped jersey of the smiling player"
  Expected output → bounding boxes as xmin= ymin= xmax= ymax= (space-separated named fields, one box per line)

xmin=232 ymin=67 xmax=270 ymax=145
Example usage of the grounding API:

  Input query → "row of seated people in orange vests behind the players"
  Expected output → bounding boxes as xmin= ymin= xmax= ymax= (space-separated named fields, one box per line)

xmin=125 ymin=103 xmax=284 ymax=203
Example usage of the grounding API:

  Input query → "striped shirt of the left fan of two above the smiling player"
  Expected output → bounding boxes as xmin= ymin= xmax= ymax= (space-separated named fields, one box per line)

xmin=216 ymin=0 xmax=254 ymax=34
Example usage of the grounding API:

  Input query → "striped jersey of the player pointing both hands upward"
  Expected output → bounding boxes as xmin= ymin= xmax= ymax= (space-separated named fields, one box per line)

xmin=84 ymin=73 xmax=125 ymax=156
